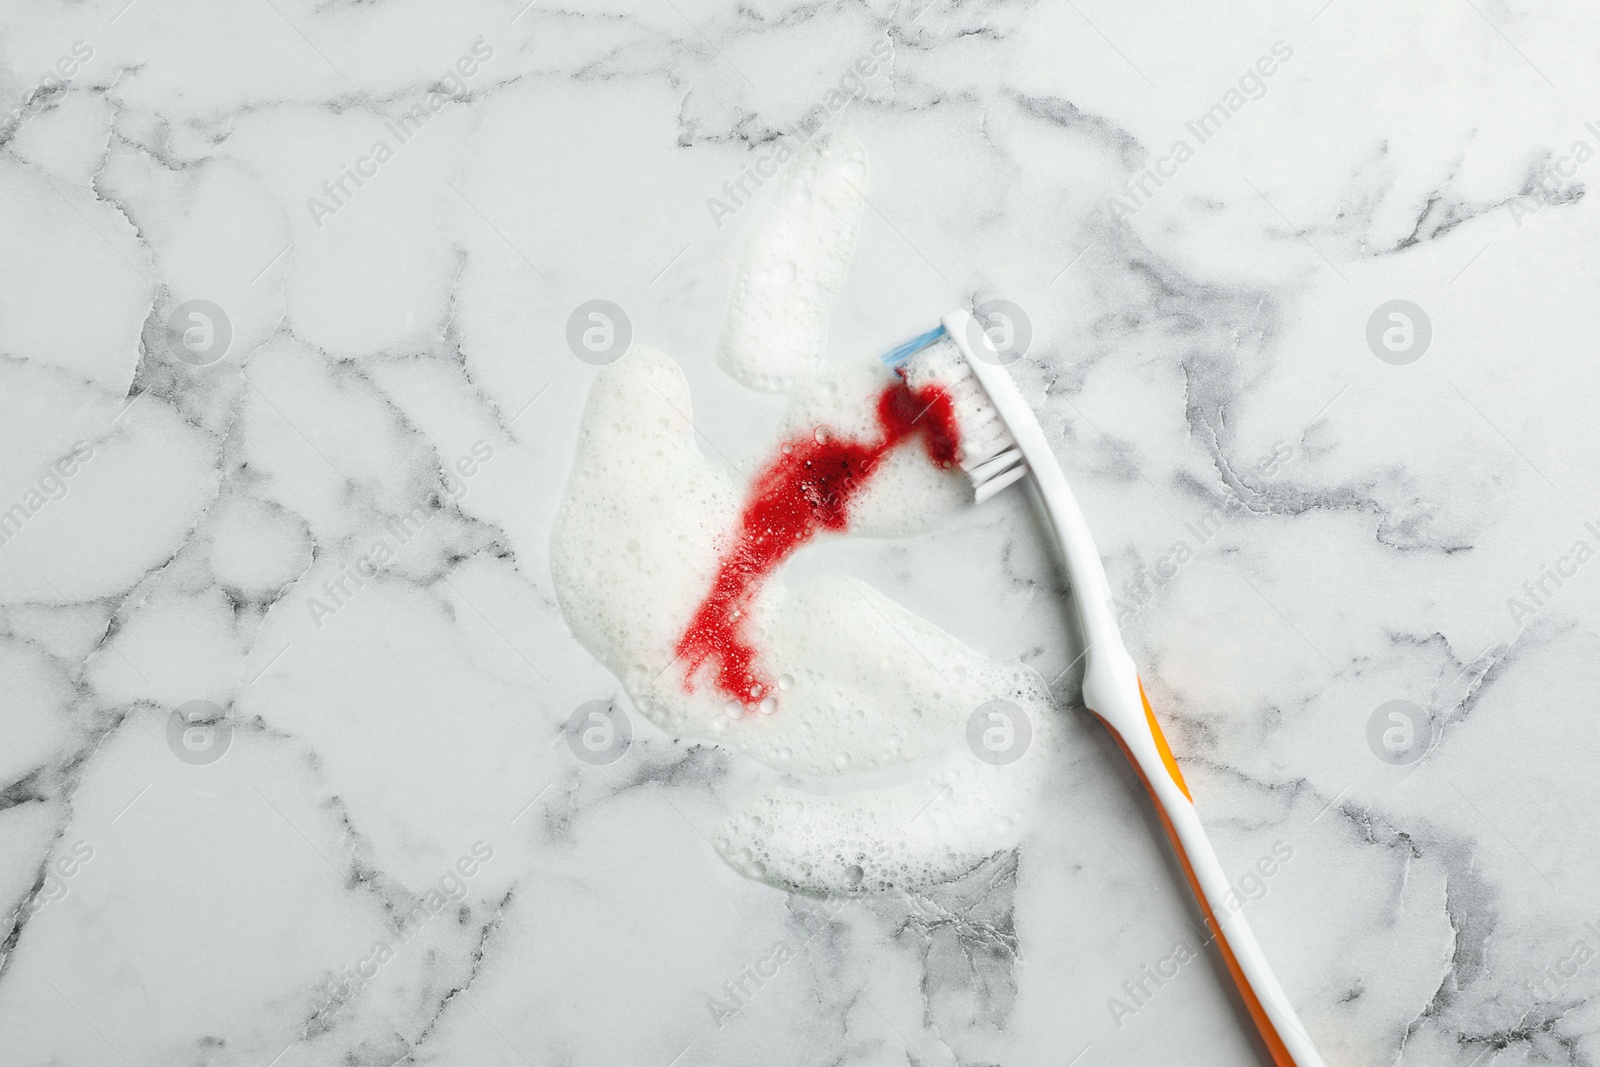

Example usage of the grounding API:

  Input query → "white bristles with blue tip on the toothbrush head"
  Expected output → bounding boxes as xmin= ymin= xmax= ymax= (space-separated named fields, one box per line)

xmin=880 ymin=312 xmax=1027 ymax=504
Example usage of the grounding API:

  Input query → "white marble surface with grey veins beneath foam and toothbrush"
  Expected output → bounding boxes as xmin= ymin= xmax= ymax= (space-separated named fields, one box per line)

xmin=0 ymin=0 xmax=1600 ymax=1067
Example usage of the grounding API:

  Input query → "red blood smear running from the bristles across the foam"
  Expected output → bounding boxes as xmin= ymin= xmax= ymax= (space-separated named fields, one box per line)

xmin=677 ymin=379 xmax=960 ymax=704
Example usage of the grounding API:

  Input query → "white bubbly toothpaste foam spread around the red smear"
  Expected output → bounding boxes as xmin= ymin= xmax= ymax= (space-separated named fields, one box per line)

xmin=550 ymin=141 xmax=1054 ymax=893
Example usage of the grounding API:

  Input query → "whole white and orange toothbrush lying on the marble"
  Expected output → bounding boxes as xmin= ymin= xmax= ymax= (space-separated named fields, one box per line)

xmin=882 ymin=310 xmax=1323 ymax=1067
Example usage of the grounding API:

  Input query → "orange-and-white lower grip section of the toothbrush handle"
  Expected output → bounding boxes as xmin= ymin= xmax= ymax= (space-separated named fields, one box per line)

xmin=1094 ymin=678 xmax=1323 ymax=1067
